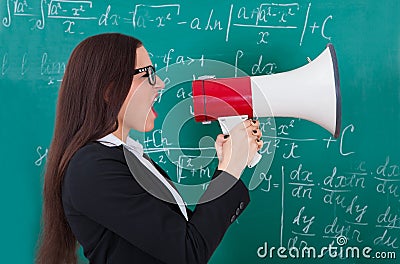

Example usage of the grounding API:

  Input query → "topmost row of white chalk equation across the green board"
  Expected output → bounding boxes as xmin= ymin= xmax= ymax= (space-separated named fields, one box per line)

xmin=1 ymin=0 xmax=333 ymax=46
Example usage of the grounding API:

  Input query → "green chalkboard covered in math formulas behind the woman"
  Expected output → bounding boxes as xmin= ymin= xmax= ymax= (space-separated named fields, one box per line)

xmin=0 ymin=0 xmax=400 ymax=264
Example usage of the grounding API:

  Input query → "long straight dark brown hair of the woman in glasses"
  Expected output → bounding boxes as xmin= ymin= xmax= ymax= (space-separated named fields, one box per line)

xmin=36 ymin=33 xmax=142 ymax=264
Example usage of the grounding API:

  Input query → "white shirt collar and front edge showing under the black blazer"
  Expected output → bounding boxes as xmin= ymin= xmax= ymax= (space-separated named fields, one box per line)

xmin=97 ymin=133 xmax=188 ymax=221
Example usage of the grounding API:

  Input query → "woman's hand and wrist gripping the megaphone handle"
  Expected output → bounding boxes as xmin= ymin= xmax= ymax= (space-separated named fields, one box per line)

xmin=215 ymin=119 xmax=263 ymax=179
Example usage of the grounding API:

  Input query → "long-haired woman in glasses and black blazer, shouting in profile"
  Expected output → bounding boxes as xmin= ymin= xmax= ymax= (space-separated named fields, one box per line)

xmin=37 ymin=34 xmax=262 ymax=264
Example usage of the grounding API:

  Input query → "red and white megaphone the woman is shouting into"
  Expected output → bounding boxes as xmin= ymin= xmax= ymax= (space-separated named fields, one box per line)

xmin=192 ymin=44 xmax=341 ymax=167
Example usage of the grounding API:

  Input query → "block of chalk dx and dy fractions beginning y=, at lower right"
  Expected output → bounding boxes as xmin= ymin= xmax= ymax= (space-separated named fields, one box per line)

xmin=259 ymin=156 xmax=400 ymax=250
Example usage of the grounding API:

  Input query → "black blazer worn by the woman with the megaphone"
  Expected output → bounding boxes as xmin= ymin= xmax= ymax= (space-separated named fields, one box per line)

xmin=62 ymin=142 xmax=250 ymax=264
